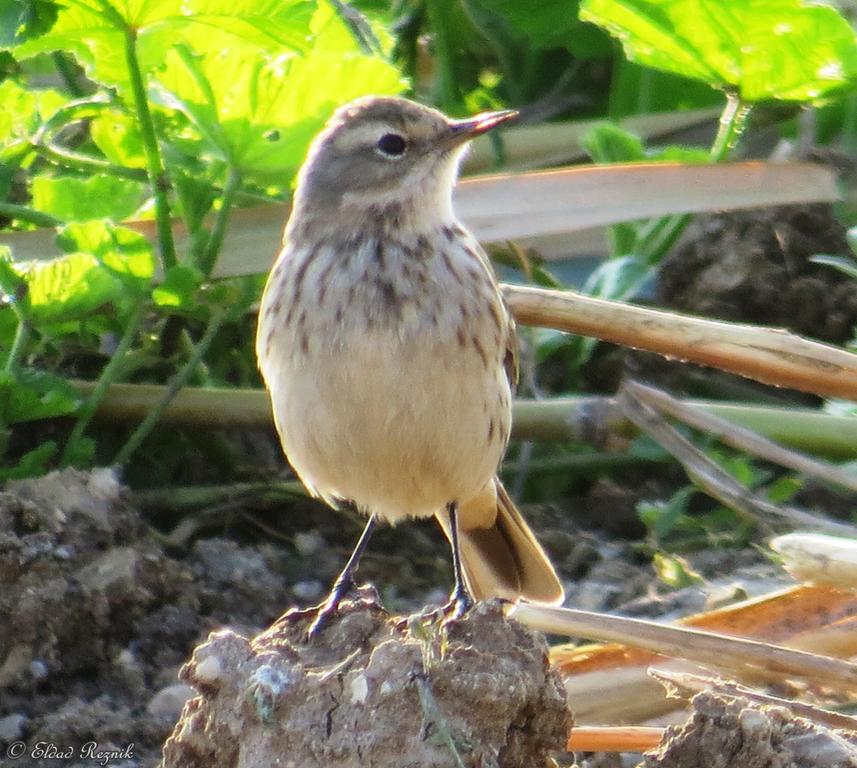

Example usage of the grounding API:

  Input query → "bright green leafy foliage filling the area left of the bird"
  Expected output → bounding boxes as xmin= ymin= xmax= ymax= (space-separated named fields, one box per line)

xmin=0 ymin=0 xmax=405 ymax=476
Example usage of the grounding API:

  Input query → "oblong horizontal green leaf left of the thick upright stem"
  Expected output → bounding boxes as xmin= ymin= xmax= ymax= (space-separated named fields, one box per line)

xmin=32 ymin=174 xmax=146 ymax=222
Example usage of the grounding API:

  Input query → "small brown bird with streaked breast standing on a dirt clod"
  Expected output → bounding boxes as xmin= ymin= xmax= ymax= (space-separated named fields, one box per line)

xmin=256 ymin=97 xmax=563 ymax=631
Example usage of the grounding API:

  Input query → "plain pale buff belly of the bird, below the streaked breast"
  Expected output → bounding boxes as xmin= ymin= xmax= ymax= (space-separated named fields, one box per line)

xmin=266 ymin=329 xmax=511 ymax=522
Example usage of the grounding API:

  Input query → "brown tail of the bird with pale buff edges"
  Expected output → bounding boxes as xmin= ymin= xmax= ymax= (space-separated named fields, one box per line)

xmin=438 ymin=477 xmax=565 ymax=605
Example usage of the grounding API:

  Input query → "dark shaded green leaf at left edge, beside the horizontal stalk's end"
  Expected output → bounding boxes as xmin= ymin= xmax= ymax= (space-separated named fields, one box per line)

xmin=0 ymin=370 xmax=79 ymax=425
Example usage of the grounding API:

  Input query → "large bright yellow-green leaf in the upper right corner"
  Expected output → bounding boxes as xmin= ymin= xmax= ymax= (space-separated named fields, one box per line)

xmin=581 ymin=0 xmax=857 ymax=102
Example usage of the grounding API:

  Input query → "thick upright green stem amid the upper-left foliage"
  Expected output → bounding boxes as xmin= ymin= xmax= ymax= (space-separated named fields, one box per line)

xmin=125 ymin=26 xmax=176 ymax=271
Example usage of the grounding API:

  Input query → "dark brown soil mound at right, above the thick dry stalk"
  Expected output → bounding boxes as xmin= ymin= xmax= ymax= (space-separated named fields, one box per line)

xmin=658 ymin=204 xmax=857 ymax=344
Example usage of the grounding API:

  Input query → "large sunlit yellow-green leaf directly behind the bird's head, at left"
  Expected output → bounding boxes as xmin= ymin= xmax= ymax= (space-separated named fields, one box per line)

xmin=153 ymin=3 xmax=404 ymax=182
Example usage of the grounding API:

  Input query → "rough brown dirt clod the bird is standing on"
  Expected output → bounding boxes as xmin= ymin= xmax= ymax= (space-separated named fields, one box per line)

xmin=163 ymin=595 xmax=570 ymax=768
